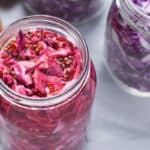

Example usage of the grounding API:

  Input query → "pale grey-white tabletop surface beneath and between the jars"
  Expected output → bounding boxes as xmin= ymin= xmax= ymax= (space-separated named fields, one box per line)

xmin=0 ymin=0 xmax=150 ymax=150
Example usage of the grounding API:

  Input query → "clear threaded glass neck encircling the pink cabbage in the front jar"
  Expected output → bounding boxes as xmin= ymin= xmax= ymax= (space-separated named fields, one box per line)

xmin=0 ymin=15 xmax=90 ymax=107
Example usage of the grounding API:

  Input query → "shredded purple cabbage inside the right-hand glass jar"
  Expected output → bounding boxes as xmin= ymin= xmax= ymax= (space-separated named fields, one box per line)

xmin=106 ymin=0 xmax=150 ymax=92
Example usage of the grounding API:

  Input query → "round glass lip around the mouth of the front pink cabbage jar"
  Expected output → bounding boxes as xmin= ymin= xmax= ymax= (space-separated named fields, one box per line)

xmin=0 ymin=15 xmax=90 ymax=107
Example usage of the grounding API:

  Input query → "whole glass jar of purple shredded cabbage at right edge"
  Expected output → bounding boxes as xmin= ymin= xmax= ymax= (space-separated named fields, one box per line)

xmin=105 ymin=0 xmax=150 ymax=96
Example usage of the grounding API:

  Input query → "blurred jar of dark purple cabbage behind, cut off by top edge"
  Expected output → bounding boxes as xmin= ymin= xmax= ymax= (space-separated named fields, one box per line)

xmin=24 ymin=0 xmax=105 ymax=24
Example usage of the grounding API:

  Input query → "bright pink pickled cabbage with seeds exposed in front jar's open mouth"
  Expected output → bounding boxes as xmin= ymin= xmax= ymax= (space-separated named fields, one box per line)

xmin=0 ymin=29 xmax=82 ymax=97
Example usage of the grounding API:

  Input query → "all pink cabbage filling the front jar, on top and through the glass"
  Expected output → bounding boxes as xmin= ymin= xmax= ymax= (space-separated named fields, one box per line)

xmin=0 ymin=28 xmax=96 ymax=150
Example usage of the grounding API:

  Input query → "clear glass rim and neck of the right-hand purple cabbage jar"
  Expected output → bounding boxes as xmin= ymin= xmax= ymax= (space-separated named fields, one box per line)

xmin=116 ymin=0 xmax=150 ymax=35
